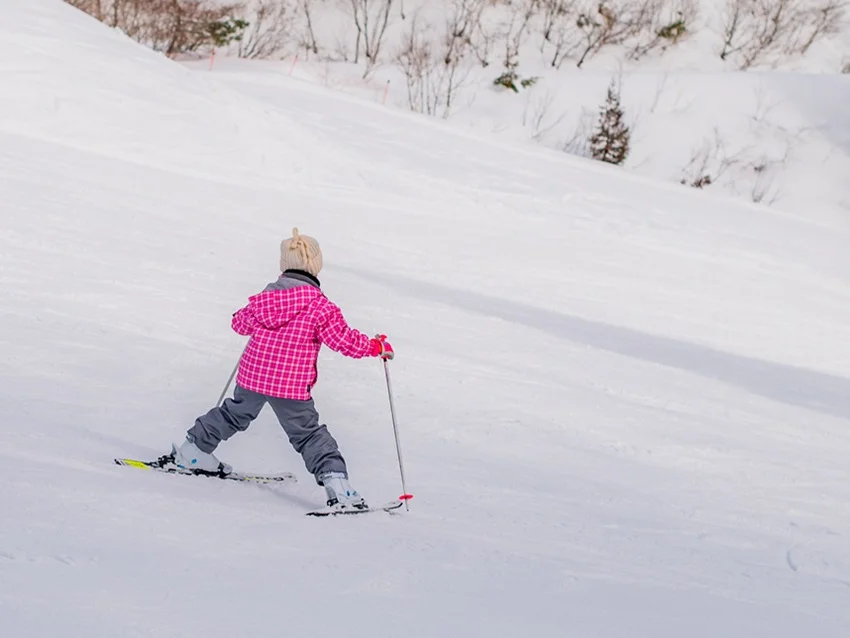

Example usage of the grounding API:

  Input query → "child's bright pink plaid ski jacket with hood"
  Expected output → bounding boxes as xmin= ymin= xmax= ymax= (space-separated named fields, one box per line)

xmin=232 ymin=276 xmax=371 ymax=401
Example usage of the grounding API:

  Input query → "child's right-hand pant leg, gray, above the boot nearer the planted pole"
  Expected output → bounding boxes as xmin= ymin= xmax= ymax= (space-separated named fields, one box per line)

xmin=267 ymin=397 xmax=348 ymax=477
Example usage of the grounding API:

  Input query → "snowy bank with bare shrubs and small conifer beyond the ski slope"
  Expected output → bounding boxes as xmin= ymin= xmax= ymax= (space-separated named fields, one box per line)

xmin=192 ymin=0 xmax=850 ymax=228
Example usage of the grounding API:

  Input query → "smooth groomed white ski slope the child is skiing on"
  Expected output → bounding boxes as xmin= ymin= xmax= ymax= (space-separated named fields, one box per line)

xmin=0 ymin=0 xmax=850 ymax=638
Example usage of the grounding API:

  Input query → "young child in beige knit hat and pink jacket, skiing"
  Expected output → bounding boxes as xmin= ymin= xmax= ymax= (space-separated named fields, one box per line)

xmin=172 ymin=228 xmax=394 ymax=508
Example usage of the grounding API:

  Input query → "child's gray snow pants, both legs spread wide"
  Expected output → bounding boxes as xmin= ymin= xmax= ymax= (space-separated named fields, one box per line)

xmin=188 ymin=385 xmax=348 ymax=477
